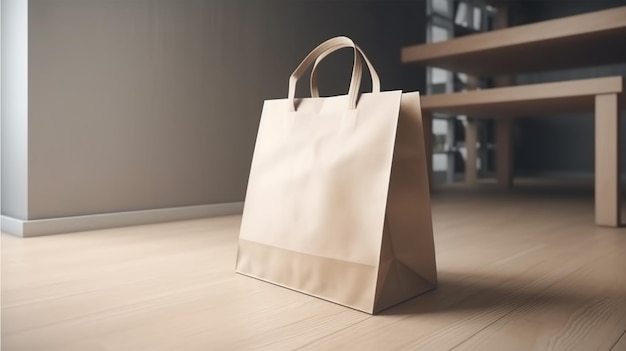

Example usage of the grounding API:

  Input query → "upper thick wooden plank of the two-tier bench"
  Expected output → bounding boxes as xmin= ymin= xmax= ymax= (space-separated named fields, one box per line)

xmin=401 ymin=6 xmax=626 ymax=76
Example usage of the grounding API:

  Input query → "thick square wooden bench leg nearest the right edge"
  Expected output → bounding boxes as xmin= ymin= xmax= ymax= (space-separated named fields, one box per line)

xmin=595 ymin=94 xmax=621 ymax=227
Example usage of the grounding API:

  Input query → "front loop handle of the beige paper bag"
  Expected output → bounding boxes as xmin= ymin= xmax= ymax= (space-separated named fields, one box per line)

xmin=287 ymin=36 xmax=363 ymax=111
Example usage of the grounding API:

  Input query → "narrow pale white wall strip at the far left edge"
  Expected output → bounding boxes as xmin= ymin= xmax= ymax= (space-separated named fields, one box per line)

xmin=0 ymin=0 xmax=28 ymax=219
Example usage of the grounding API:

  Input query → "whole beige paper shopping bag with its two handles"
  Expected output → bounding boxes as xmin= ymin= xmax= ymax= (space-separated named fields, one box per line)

xmin=236 ymin=37 xmax=437 ymax=313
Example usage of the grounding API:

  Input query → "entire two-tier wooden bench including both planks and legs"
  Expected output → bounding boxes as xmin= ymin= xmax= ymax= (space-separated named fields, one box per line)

xmin=401 ymin=4 xmax=626 ymax=226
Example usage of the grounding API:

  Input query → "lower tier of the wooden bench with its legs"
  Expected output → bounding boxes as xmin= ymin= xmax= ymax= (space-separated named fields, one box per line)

xmin=421 ymin=77 xmax=626 ymax=227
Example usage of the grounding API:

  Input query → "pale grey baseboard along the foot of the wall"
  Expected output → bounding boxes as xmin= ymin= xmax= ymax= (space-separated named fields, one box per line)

xmin=1 ymin=202 xmax=243 ymax=238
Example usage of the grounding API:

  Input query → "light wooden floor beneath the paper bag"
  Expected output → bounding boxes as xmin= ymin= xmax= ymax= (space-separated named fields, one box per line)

xmin=2 ymin=183 xmax=626 ymax=351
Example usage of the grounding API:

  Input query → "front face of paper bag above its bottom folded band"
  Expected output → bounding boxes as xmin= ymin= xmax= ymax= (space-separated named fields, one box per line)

xmin=240 ymin=91 xmax=401 ymax=266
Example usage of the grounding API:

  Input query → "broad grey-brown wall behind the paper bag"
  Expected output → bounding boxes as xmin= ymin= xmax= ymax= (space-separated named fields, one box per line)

xmin=3 ymin=0 xmax=425 ymax=219
